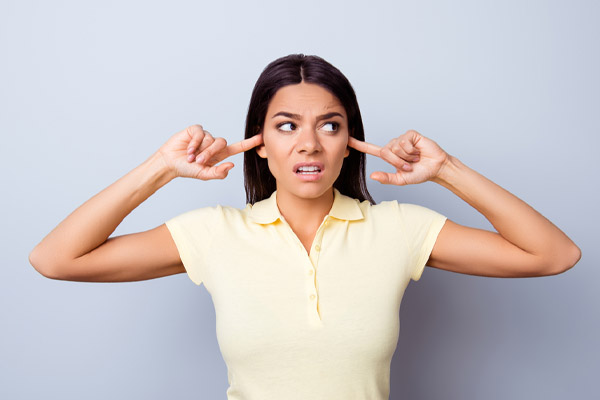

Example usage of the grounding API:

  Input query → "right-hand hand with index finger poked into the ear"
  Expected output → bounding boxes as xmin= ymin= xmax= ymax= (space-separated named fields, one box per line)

xmin=348 ymin=130 xmax=450 ymax=185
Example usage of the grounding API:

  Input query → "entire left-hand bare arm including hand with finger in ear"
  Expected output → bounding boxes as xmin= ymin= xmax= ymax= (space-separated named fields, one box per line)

xmin=29 ymin=125 xmax=262 ymax=282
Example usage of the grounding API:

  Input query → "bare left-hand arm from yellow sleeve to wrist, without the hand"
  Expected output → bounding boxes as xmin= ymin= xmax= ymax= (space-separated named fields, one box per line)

xmin=29 ymin=155 xmax=179 ymax=282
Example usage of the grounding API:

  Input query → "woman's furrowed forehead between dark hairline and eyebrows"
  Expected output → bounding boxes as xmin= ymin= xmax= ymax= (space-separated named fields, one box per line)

xmin=267 ymin=82 xmax=346 ymax=115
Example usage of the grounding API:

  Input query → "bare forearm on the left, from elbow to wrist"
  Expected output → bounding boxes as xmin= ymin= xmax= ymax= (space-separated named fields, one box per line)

xmin=30 ymin=154 xmax=173 ymax=268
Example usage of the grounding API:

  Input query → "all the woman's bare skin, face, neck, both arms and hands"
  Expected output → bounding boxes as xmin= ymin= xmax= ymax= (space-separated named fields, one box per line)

xmin=29 ymin=83 xmax=581 ymax=282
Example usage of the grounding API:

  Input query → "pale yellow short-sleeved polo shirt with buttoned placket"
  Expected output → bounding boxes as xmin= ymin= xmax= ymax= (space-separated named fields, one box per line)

xmin=166 ymin=190 xmax=446 ymax=400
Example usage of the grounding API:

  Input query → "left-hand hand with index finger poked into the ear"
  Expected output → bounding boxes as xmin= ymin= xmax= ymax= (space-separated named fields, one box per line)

xmin=157 ymin=125 xmax=263 ymax=181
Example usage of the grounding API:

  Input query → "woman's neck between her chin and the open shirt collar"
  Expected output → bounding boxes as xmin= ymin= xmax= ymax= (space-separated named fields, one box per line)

xmin=277 ymin=187 xmax=333 ymax=229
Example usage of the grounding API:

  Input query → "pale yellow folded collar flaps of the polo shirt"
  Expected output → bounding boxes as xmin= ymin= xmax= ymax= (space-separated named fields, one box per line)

xmin=248 ymin=188 xmax=364 ymax=224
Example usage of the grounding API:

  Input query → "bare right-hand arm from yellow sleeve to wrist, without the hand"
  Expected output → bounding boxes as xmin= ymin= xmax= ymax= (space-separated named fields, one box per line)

xmin=428 ymin=157 xmax=581 ymax=277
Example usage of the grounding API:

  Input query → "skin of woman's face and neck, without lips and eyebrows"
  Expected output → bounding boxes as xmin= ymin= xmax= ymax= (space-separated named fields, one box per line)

xmin=256 ymin=83 xmax=350 ymax=251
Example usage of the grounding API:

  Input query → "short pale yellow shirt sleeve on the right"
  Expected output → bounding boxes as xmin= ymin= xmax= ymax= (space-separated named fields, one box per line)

xmin=398 ymin=204 xmax=446 ymax=281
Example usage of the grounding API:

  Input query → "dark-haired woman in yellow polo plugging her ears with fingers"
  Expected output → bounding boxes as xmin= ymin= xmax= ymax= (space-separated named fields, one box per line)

xmin=30 ymin=55 xmax=580 ymax=399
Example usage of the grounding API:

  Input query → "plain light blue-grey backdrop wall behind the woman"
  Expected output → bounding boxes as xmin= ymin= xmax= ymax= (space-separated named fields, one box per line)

xmin=0 ymin=0 xmax=600 ymax=400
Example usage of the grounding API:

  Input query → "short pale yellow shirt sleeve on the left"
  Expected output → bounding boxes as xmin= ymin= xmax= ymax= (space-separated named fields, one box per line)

xmin=165 ymin=207 xmax=217 ymax=285
